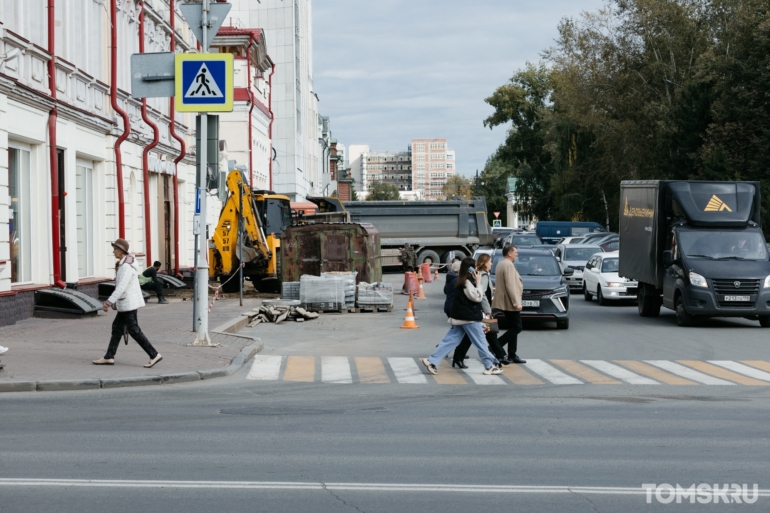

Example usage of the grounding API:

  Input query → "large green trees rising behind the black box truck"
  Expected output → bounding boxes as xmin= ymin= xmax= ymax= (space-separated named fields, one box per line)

xmin=484 ymin=0 xmax=770 ymax=229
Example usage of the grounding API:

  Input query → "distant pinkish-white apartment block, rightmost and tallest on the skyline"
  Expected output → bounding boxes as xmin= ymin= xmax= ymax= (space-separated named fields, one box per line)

xmin=411 ymin=139 xmax=457 ymax=200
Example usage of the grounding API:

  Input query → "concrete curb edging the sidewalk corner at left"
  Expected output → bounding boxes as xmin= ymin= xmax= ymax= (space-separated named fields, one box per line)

xmin=0 ymin=342 xmax=264 ymax=393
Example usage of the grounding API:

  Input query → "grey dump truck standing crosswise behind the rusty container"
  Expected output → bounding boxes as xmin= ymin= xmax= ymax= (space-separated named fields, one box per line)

xmin=343 ymin=198 xmax=494 ymax=267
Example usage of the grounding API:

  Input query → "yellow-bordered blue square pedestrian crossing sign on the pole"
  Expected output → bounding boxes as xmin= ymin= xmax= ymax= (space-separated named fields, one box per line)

xmin=174 ymin=53 xmax=233 ymax=112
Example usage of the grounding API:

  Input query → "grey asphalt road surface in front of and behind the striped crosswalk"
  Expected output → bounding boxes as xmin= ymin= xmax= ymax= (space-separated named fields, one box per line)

xmin=0 ymin=285 xmax=770 ymax=513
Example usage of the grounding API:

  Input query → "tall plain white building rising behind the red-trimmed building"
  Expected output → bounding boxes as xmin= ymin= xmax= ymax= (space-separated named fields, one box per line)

xmin=226 ymin=0 xmax=325 ymax=201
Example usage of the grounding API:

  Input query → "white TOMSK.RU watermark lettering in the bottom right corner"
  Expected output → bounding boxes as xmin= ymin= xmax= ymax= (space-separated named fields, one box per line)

xmin=642 ymin=483 xmax=760 ymax=504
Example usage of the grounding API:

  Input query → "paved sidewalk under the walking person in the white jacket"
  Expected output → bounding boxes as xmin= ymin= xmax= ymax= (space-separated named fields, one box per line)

xmin=0 ymin=298 xmax=261 ymax=390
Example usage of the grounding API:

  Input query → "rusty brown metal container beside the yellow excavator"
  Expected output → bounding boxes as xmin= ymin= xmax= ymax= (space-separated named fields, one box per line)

xmin=281 ymin=223 xmax=382 ymax=283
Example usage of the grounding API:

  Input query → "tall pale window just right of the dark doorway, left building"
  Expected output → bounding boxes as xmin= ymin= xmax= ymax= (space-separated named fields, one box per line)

xmin=75 ymin=160 xmax=95 ymax=278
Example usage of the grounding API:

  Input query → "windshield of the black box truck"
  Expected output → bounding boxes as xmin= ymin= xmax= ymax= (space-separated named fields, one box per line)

xmin=678 ymin=230 xmax=767 ymax=260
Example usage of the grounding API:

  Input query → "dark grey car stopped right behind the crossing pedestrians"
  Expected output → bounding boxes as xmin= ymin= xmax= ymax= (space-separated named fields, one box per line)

xmin=490 ymin=249 xmax=574 ymax=330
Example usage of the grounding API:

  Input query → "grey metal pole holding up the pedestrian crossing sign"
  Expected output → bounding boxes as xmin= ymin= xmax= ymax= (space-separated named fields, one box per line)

xmin=195 ymin=0 xmax=212 ymax=346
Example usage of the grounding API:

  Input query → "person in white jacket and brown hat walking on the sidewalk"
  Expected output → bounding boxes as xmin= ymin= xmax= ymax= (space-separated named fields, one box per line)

xmin=93 ymin=239 xmax=163 ymax=368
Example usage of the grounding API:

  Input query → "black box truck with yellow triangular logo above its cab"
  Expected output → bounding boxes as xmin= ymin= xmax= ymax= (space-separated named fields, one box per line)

xmin=619 ymin=180 xmax=770 ymax=328
